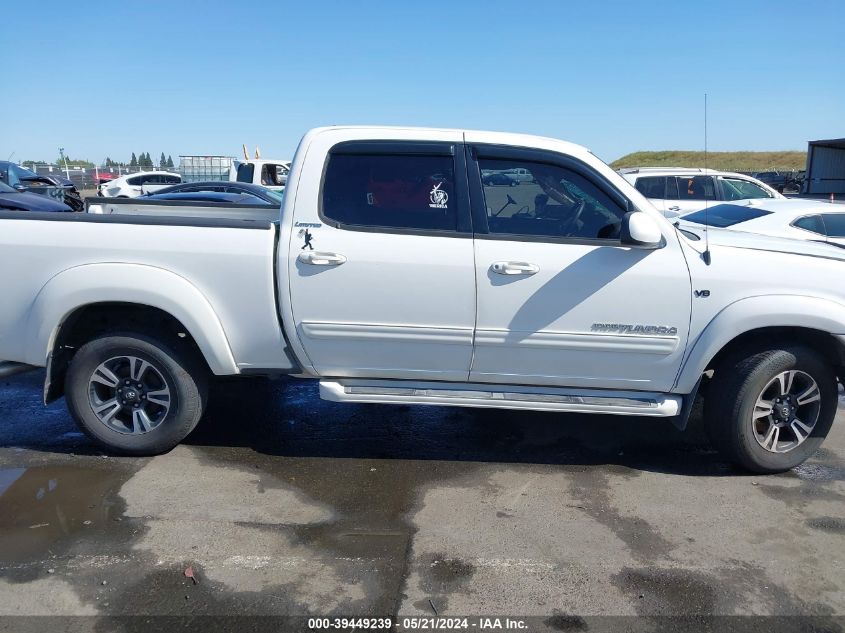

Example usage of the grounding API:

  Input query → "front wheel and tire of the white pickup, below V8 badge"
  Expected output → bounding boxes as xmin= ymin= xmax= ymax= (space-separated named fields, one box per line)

xmin=704 ymin=346 xmax=839 ymax=474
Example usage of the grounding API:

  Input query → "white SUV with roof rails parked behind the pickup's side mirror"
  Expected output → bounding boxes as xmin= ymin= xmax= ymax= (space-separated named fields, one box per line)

xmin=619 ymin=167 xmax=783 ymax=218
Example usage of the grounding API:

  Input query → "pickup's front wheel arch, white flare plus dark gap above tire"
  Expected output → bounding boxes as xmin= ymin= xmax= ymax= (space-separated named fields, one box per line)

xmin=675 ymin=295 xmax=845 ymax=393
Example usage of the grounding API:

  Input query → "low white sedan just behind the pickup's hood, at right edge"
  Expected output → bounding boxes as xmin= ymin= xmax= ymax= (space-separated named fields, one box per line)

xmin=676 ymin=200 xmax=845 ymax=248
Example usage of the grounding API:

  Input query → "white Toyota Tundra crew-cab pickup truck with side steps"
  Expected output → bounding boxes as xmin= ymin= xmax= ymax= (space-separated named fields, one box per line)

xmin=0 ymin=127 xmax=845 ymax=472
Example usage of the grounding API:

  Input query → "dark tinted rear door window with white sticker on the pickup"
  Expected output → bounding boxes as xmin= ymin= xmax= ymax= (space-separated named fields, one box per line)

xmin=322 ymin=154 xmax=458 ymax=231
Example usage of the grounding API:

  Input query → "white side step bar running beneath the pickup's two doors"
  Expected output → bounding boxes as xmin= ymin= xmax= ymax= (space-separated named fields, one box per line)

xmin=320 ymin=379 xmax=683 ymax=418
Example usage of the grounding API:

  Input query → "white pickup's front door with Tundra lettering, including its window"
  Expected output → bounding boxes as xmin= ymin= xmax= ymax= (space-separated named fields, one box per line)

xmin=467 ymin=141 xmax=691 ymax=391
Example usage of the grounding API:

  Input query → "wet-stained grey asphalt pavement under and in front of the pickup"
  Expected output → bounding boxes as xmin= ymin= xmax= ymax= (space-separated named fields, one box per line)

xmin=0 ymin=372 xmax=845 ymax=631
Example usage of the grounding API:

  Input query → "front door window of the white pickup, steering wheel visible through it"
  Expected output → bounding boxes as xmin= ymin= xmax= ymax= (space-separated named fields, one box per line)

xmin=479 ymin=159 xmax=625 ymax=239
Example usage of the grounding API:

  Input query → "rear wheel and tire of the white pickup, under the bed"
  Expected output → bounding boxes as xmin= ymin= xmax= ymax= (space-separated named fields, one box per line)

xmin=65 ymin=332 xmax=208 ymax=455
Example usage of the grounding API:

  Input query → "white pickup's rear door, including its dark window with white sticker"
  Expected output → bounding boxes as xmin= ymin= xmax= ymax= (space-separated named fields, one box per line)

xmin=287 ymin=130 xmax=475 ymax=381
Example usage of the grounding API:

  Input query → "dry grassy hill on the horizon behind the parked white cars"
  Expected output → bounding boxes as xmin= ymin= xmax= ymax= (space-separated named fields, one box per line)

xmin=610 ymin=151 xmax=807 ymax=171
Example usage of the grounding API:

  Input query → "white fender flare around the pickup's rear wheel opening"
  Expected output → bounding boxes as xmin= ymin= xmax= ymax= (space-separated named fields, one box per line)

xmin=25 ymin=263 xmax=238 ymax=375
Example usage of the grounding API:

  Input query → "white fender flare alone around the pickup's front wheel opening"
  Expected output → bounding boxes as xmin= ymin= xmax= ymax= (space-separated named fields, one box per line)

xmin=673 ymin=295 xmax=845 ymax=393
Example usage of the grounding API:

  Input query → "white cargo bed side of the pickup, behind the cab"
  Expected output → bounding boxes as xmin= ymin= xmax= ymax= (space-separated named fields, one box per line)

xmin=0 ymin=211 xmax=289 ymax=373
